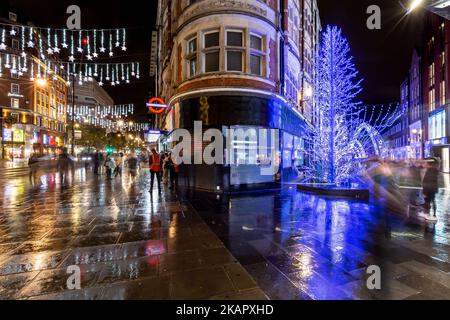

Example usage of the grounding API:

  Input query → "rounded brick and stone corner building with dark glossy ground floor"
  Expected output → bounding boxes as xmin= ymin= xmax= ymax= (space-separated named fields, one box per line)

xmin=157 ymin=0 xmax=320 ymax=191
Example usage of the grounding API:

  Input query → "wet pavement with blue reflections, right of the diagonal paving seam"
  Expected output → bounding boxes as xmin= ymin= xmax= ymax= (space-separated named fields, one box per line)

xmin=190 ymin=188 xmax=450 ymax=299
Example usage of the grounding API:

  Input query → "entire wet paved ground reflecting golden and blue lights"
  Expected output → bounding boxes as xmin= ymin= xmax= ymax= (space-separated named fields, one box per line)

xmin=0 ymin=169 xmax=450 ymax=299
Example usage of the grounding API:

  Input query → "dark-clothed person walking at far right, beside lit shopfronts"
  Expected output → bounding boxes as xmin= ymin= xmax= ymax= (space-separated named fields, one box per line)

xmin=422 ymin=160 xmax=439 ymax=221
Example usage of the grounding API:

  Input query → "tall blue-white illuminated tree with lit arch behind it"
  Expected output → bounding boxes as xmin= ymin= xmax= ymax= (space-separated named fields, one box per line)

xmin=304 ymin=26 xmax=397 ymax=185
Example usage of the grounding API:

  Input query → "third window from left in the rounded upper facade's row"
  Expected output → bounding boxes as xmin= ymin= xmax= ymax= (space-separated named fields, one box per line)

xmin=225 ymin=30 xmax=245 ymax=72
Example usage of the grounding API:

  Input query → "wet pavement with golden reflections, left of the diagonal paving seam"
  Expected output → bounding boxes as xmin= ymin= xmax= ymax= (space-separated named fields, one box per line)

xmin=0 ymin=169 xmax=267 ymax=299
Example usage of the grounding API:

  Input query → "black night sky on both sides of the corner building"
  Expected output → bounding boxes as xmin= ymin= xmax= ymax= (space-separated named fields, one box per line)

xmin=2 ymin=0 xmax=422 ymax=115
